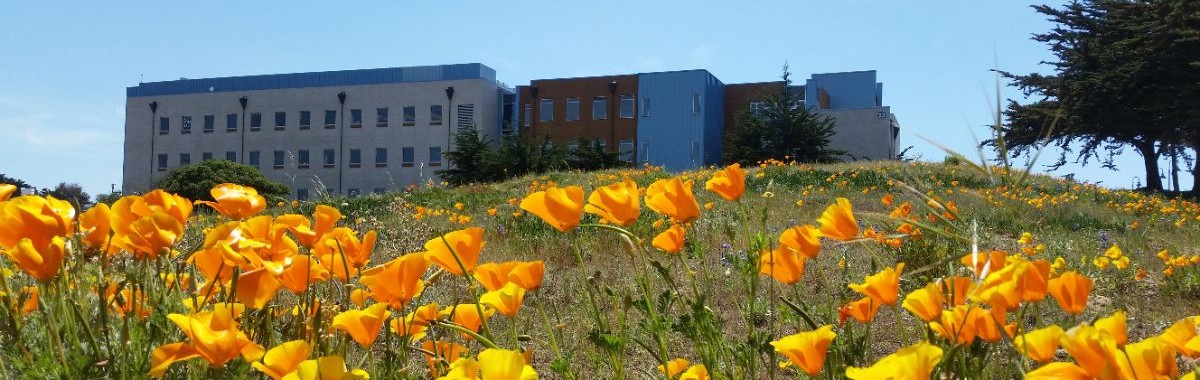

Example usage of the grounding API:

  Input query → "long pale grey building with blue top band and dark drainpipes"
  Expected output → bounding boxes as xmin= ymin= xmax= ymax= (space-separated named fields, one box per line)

xmin=122 ymin=64 xmax=514 ymax=199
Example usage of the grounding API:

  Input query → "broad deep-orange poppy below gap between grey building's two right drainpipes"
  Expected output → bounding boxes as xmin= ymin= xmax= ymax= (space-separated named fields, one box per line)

xmin=359 ymin=253 xmax=430 ymax=310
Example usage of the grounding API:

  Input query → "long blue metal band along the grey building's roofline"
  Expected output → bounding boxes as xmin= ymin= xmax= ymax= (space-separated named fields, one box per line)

xmin=125 ymin=64 xmax=496 ymax=97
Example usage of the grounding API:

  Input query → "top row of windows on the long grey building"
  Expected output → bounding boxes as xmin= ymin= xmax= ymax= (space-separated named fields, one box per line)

xmin=158 ymin=105 xmax=443 ymax=134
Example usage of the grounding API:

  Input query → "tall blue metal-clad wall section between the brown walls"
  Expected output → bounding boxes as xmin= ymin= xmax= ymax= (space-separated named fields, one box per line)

xmin=636 ymin=70 xmax=725 ymax=170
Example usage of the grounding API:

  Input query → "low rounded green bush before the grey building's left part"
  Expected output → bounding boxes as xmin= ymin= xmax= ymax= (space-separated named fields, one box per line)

xmin=155 ymin=159 xmax=290 ymax=203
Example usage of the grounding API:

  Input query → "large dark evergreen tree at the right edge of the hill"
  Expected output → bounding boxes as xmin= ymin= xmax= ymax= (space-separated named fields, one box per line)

xmin=1001 ymin=0 xmax=1200 ymax=191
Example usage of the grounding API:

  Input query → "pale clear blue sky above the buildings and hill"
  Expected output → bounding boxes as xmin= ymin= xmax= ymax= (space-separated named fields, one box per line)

xmin=0 ymin=0 xmax=1190 ymax=194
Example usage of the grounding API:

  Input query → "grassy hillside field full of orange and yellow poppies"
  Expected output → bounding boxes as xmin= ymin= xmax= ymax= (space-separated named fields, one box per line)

xmin=0 ymin=158 xmax=1200 ymax=379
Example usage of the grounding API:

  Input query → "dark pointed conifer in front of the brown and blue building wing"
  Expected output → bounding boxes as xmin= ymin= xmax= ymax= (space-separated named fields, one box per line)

xmin=725 ymin=65 xmax=845 ymax=165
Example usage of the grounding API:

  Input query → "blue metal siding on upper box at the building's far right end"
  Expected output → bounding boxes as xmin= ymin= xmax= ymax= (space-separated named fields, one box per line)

xmin=804 ymin=70 xmax=881 ymax=109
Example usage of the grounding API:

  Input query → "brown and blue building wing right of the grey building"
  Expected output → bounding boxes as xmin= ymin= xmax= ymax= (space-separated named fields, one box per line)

xmin=517 ymin=70 xmax=899 ymax=170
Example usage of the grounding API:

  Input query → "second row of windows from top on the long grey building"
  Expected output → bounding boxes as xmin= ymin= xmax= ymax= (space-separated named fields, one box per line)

xmin=157 ymin=146 xmax=442 ymax=171
